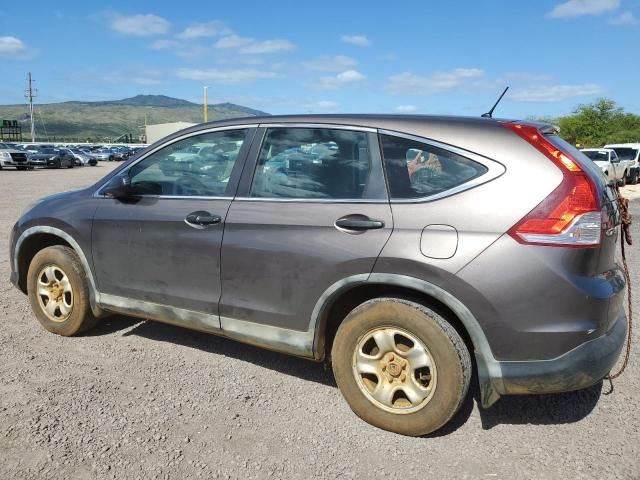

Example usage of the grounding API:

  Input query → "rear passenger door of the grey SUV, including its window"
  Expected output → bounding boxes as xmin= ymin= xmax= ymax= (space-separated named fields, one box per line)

xmin=220 ymin=125 xmax=393 ymax=331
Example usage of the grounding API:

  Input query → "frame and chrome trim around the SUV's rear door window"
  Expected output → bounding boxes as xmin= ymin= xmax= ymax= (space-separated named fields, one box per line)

xmin=240 ymin=122 xmax=389 ymax=204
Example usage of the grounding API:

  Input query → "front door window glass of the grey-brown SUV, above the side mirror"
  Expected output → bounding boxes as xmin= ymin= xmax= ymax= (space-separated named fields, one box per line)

xmin=129 ymin=129 xmax=248 ymax=197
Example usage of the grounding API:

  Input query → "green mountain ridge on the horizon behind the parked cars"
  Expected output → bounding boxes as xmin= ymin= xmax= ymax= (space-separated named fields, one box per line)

xmin=0 ymin=95 xmax=269 ymax=141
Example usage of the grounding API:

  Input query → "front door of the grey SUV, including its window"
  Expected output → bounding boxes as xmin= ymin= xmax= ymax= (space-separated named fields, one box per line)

xmin=92 ymin=128 xmax=255 ymax=327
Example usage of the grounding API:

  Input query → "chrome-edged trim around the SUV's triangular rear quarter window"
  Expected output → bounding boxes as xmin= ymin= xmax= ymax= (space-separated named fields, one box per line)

xmin=378 ymin=128 xmax=507 ymax=204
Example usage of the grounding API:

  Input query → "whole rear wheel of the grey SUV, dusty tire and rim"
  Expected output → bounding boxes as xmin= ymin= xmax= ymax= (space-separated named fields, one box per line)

xmin=331 ymin=298 xmax=471 ymax=436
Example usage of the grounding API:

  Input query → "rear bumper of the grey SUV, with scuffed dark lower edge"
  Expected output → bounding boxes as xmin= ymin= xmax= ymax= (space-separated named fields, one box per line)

xmin=478 ymin=313 xmax=627 ymax=408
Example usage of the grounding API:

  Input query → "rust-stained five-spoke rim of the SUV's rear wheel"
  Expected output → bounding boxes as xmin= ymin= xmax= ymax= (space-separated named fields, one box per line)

xmin=352 ymin=327 xmax=437 ymax=414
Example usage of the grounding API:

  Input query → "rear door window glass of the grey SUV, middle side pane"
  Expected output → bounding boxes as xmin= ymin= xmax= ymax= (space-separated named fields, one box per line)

xmin=251 ymin=127 xmax=371 ymax=199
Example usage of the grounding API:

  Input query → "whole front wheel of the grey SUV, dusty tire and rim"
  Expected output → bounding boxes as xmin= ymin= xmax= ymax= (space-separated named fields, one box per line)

xmin=27 ymin=245 xmax=97 ymax=337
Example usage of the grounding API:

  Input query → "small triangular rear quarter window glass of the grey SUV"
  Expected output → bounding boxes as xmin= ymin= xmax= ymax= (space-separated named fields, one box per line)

xmin=380 ymin=135 xmax=488 ymax=199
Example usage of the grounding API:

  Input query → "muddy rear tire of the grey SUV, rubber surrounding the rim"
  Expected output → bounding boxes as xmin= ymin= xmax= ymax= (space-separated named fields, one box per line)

xmin=331 ymin=298 xmax=472 ymax=436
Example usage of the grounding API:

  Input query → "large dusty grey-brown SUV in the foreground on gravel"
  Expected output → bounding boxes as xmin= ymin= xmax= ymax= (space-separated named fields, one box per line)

xmin=10 ymin=115 xmax=627 ymax=435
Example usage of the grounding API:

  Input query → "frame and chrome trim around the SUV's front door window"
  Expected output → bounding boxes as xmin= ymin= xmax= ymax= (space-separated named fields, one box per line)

xmin=93 ymin=123 xmax=258 ymax=200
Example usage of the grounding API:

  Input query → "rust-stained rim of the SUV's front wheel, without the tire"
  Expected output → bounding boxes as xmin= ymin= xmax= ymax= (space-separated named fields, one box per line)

xmin=37 ymin=265 xmax=73 ymax=322
